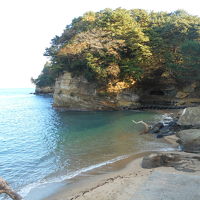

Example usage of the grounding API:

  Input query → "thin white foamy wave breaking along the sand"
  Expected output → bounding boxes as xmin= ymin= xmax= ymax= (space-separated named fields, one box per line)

xmin=19 ymin=155 xmax=129 ymax=197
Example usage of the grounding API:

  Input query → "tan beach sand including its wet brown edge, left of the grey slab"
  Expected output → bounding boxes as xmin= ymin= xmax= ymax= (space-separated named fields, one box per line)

xmin=44 ymin=151 xmax=177 ymax=200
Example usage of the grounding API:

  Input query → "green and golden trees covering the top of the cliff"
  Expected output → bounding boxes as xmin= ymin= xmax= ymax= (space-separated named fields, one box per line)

xmin=33 ymin=8 xmax=200 ymax=87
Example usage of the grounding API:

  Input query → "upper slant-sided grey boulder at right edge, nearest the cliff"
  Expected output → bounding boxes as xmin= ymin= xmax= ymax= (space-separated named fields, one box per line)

xmin=177 ymin=106 xmax=200 ymax=127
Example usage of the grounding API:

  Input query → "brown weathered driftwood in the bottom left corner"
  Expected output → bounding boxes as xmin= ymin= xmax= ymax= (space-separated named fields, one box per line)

xmin=0 ymin=177 xmax=22 ymax=200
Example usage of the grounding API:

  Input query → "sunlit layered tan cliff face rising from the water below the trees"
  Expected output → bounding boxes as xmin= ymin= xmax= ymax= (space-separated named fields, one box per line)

xmin=54 ymin=72 xmax=139 ymax=110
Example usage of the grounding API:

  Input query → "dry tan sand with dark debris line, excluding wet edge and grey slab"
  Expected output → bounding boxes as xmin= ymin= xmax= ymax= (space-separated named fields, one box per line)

xmin=47 ymin=158 xmax=153 ymax=200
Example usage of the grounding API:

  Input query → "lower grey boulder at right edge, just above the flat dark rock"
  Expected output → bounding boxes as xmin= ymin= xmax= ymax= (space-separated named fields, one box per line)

xmin=176 ymin=129 xmax=200 ymax=153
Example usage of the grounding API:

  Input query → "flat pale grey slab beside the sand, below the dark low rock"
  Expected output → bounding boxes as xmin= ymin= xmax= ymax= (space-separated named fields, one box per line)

xmin=130 ymin=171 xmax=200 ymax=200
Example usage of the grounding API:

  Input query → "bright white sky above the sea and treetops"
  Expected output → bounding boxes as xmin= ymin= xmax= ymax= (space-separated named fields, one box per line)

xmin=0 ymin=0 xmax=200 ymax=88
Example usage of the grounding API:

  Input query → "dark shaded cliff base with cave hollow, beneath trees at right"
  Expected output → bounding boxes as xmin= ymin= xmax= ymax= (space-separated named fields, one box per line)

xmin=138 ymin=76 xmax=200 ymax=108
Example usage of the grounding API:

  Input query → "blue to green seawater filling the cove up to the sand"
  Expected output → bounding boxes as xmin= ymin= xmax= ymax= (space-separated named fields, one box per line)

xmin=0 ymin=89 xmax=172 ymax=199
